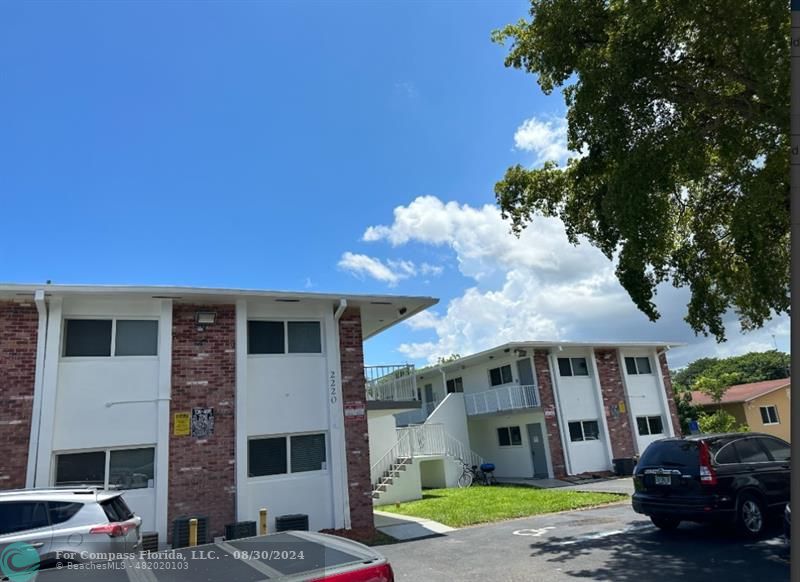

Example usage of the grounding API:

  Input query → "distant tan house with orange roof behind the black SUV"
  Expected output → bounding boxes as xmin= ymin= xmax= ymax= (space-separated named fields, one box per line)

xmin=692 ymin=378 xmax=791 ymax=442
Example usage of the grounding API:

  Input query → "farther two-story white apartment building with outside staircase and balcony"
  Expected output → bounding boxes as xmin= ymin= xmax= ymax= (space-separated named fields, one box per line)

xmin=370 ymin=341 xmax=680 ymax=504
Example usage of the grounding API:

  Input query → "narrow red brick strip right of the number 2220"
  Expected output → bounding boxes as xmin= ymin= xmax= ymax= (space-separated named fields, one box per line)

xmin=339 ymin=307 xmax=375 ymax=536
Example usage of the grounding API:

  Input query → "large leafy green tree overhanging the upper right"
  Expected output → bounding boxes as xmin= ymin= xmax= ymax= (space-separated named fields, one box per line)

xmin=493 ymin=0 xmax=790 ymax=341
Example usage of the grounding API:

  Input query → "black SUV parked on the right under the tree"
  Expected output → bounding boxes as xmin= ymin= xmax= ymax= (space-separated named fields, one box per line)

xmin=632 ymin=433 xmax=791 ymax=537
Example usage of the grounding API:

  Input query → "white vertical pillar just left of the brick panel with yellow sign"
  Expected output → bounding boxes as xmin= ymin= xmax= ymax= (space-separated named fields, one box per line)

xmin=155 ymin=299 xmax=172 ymax=544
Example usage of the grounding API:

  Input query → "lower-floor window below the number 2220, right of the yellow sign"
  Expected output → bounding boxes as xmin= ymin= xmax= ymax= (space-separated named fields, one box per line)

xmin=247 ymin=433 xmax=327 ymax=477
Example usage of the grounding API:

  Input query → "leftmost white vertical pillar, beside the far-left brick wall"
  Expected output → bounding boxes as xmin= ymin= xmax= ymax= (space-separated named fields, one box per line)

xmin=33 ymin=297 xmax=63 ymax=487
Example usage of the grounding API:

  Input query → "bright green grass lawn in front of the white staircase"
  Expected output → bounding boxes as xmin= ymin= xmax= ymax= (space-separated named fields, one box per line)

xmin=376 ymin=485 xmax=628 ymax=527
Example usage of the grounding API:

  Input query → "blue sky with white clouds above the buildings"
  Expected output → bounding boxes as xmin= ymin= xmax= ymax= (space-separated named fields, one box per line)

xmin=0 ymin=1 xmax=788 ymax=370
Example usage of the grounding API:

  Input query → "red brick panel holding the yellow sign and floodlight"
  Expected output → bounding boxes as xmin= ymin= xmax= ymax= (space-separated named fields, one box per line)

xmin=168 ymin=305 xmax=236 ymax=540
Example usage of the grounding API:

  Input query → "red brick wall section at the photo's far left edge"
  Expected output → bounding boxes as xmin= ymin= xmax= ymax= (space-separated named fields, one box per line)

xmin=0 ymin=302 xmax=39 ymax=489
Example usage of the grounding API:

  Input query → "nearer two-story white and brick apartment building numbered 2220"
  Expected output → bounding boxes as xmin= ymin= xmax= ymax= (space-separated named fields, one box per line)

xmin=0 ymin=285 xmax=436 ymax=542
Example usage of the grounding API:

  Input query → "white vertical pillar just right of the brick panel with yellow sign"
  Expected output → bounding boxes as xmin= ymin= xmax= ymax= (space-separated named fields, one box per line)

xmin=235 ymin=299 xmax=247 ymax=521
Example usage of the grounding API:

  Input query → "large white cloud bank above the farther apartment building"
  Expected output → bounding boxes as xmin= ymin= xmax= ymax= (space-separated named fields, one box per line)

xmin=363 ymin=196 xmax=788 ymax=366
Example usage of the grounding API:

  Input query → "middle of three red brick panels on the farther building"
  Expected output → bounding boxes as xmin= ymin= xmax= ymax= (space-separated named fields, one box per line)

xmin=594 ymin=349 xmax=636 ymax=459
